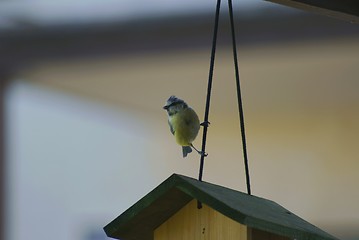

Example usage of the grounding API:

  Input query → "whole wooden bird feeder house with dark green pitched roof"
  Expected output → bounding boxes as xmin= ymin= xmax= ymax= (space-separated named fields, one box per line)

xmin=104 ymin=174 xmax=337 ymax=240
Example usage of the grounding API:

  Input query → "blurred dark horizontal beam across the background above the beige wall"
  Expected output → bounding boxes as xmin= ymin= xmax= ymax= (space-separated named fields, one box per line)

xmin=0 ymin=12 xmax=359 ymax=72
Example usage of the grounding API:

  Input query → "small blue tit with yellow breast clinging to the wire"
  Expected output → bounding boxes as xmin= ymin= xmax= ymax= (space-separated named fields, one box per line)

xmin=163 ymin=96 xmax=201 ymax=157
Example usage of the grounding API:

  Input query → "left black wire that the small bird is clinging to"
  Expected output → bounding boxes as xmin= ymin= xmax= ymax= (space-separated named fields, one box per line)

xmin=198 ymin=0 xmax=221 ymax=181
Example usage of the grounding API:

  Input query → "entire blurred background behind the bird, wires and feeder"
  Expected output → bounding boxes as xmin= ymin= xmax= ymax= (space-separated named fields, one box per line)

xmin=0 ymin=0 xmax=359 ymax=240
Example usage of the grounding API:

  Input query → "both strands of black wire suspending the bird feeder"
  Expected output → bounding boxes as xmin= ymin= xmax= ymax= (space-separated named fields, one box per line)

xmin=197 ymin=0 xmax=251 ymax=196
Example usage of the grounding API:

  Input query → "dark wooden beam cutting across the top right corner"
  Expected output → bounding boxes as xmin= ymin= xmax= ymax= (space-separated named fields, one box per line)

xmin=266 ymin=0 xmax=359 ymax=23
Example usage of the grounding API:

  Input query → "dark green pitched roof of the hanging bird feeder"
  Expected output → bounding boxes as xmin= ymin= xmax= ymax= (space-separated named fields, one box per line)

xmin=104 ymin=174 xmax=337 ymax=240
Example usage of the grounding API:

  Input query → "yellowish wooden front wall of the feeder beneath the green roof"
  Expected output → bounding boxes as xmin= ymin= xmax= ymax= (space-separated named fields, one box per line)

xmin=154 ymin=200 xmax=247 ymax=240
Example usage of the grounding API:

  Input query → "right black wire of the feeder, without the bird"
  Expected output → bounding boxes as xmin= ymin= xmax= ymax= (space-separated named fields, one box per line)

xmin=228 ymin=0 xmax=251 ymax=195
